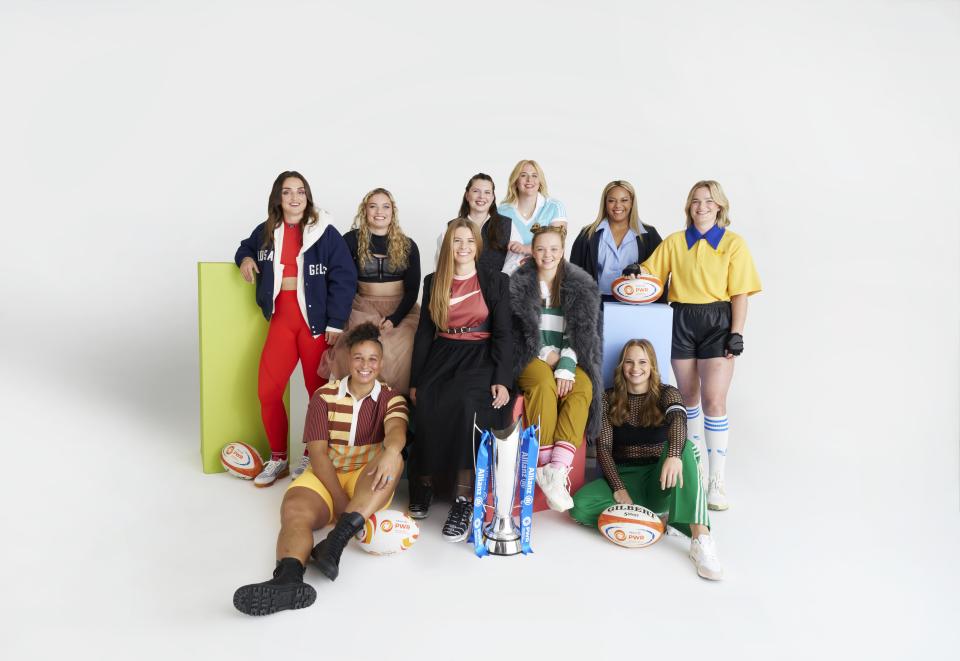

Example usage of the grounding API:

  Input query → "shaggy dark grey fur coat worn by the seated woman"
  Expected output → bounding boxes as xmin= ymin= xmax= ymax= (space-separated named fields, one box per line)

xmin=510 ymin=259 xmax=603 ymax=440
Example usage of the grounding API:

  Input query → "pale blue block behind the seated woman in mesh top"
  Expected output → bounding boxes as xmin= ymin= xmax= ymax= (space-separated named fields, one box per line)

xmin=602 ymin=301 xmax=677 ymax=388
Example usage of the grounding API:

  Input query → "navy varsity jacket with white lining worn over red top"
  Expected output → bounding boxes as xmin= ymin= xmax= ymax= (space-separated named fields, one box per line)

xmin=233 ymin=210 xmax=357 ymax=337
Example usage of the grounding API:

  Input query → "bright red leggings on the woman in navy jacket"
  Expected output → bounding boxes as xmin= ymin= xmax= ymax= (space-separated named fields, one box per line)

xmin=257 ymin=290 xmax=327 ymax=459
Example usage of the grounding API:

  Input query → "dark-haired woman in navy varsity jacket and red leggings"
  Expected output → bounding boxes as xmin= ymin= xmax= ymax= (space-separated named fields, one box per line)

xmin=234 ymin=172 xmax=357 ymax=487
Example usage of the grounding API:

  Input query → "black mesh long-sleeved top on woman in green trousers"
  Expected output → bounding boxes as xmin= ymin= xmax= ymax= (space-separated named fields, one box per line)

xmin=597 ymin=383 xmax=687 ymax=491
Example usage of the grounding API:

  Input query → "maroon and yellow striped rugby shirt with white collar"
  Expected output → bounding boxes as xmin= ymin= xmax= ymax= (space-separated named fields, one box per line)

xmin=303 ymin=377 xmax=410 ymax=473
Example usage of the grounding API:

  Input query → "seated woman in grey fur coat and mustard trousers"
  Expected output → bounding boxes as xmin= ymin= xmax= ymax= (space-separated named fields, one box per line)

xmin=510 ymin=224 xmax=603 ymax=512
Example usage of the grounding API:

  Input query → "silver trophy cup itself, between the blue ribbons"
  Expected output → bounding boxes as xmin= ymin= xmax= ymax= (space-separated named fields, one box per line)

xmin=483 ymin=420 xmax=521 ymax=555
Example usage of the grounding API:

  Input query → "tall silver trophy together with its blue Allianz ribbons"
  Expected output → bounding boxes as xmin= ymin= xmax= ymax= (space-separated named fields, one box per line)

xmin=470 ymin=420 xmax=540 ymax=558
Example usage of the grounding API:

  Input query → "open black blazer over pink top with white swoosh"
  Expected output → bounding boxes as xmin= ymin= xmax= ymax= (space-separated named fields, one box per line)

xmin=410 ymin=268 xmax=513 ymax=389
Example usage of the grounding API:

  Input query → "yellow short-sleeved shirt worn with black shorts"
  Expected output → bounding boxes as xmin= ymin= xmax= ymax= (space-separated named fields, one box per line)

xmin=642 ymin=229 xmax=761 ymax=303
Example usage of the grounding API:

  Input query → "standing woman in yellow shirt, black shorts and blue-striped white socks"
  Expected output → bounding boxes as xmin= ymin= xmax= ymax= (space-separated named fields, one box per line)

xmin=641 ymin=181 xmax=760 ymax=510
